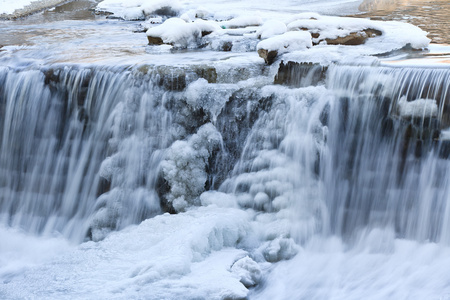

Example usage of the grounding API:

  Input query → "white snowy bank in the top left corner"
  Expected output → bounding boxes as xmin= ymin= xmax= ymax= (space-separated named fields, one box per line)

xmin=0 ymin=0 xmax=72 ymax=20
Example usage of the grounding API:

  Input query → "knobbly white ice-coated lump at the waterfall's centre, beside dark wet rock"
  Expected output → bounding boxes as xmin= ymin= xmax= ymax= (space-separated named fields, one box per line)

xmin=161 ymin=123 xmax=222 ymax=212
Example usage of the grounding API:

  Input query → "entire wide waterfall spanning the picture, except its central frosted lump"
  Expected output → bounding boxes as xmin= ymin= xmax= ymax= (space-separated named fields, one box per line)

xmin=0 ymin=65 xmax=450 ymax=243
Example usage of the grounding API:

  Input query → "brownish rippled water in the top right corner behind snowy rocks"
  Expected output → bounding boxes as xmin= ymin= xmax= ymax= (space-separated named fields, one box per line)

xmin=355 ymin=0 xmax=450 ymax=44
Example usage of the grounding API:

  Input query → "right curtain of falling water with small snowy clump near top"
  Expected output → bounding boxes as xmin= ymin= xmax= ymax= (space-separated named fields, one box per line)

xmin=322 ymin=66 xmax=450 ymax=243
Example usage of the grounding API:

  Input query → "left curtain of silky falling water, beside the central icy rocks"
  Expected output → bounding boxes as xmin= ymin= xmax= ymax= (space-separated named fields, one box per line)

xmin=0 ymin=67 xmax=178 ymax=241
